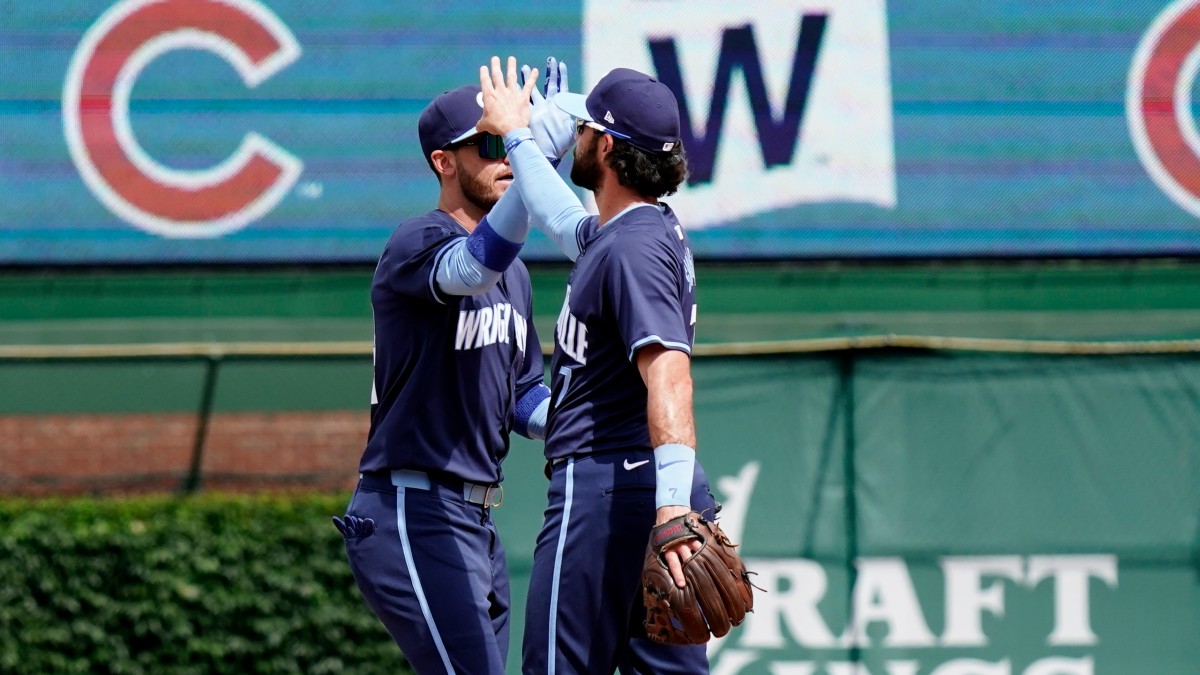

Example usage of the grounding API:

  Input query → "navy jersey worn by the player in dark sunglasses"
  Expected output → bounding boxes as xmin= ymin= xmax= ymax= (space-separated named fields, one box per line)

xmin=359 ymin=210 xmax=542 ymax=483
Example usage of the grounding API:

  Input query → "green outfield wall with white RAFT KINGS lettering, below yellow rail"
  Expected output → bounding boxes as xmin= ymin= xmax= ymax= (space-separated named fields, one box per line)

xmin=496 ymin=353 xmax=1200 ymax=675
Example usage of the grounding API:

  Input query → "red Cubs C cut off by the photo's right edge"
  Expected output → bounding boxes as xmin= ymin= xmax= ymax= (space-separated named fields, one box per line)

xmin=1126 ymin=0 xmax=1200 ymax=216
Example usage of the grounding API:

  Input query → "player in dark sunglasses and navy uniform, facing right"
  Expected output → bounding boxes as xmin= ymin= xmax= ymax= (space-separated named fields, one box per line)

xmin=334 ymin=59 xmax=550 ymax=675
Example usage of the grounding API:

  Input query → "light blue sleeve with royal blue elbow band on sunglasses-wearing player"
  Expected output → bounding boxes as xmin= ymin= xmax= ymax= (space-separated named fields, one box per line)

xmin=434 ymin=162 xmax=529 ymax=295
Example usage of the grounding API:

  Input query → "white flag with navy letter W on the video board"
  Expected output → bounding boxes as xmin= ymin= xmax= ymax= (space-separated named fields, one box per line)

xmin=580 ymin=0 xmax=896 ymax=227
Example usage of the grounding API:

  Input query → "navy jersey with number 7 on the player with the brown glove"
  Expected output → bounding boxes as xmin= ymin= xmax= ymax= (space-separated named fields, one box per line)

xmin=546 ymin=204 xmax=696 ymax=459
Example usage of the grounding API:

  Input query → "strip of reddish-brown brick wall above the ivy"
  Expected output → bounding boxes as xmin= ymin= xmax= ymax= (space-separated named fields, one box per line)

xmin=0 ymin=411 xmax=368 ymax=496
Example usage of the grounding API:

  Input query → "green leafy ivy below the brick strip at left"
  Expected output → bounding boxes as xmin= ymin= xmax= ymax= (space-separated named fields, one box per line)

xmin=0 ymin=494 xmax=407 ymax=675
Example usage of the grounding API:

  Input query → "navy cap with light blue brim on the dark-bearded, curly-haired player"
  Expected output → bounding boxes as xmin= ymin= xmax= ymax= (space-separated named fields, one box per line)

xmin=553 ymin=68 xmax=679 ymax=153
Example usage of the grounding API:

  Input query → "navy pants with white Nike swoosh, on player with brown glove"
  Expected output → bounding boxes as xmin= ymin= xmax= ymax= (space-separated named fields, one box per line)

xmin=522 ymin=449 xmax=715 ymax=675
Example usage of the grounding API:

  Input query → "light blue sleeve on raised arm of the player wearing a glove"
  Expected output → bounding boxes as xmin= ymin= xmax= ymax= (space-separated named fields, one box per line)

xmin=504 ymin=129 xmax=590 ymax=261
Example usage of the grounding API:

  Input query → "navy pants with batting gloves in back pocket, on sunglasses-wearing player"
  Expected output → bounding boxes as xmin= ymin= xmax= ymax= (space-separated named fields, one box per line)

xmin=346 ymin=472 xmax=509 ymax=675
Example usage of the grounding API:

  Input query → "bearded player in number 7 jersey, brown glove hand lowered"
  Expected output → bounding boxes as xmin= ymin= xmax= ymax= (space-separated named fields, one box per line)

xmin=484 ymin=61 xmax=715 ymax=675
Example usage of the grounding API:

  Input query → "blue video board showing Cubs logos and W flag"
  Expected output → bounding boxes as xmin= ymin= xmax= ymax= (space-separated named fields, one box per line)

xmin=0 ymin=0 xmax=1200 ymax=264
